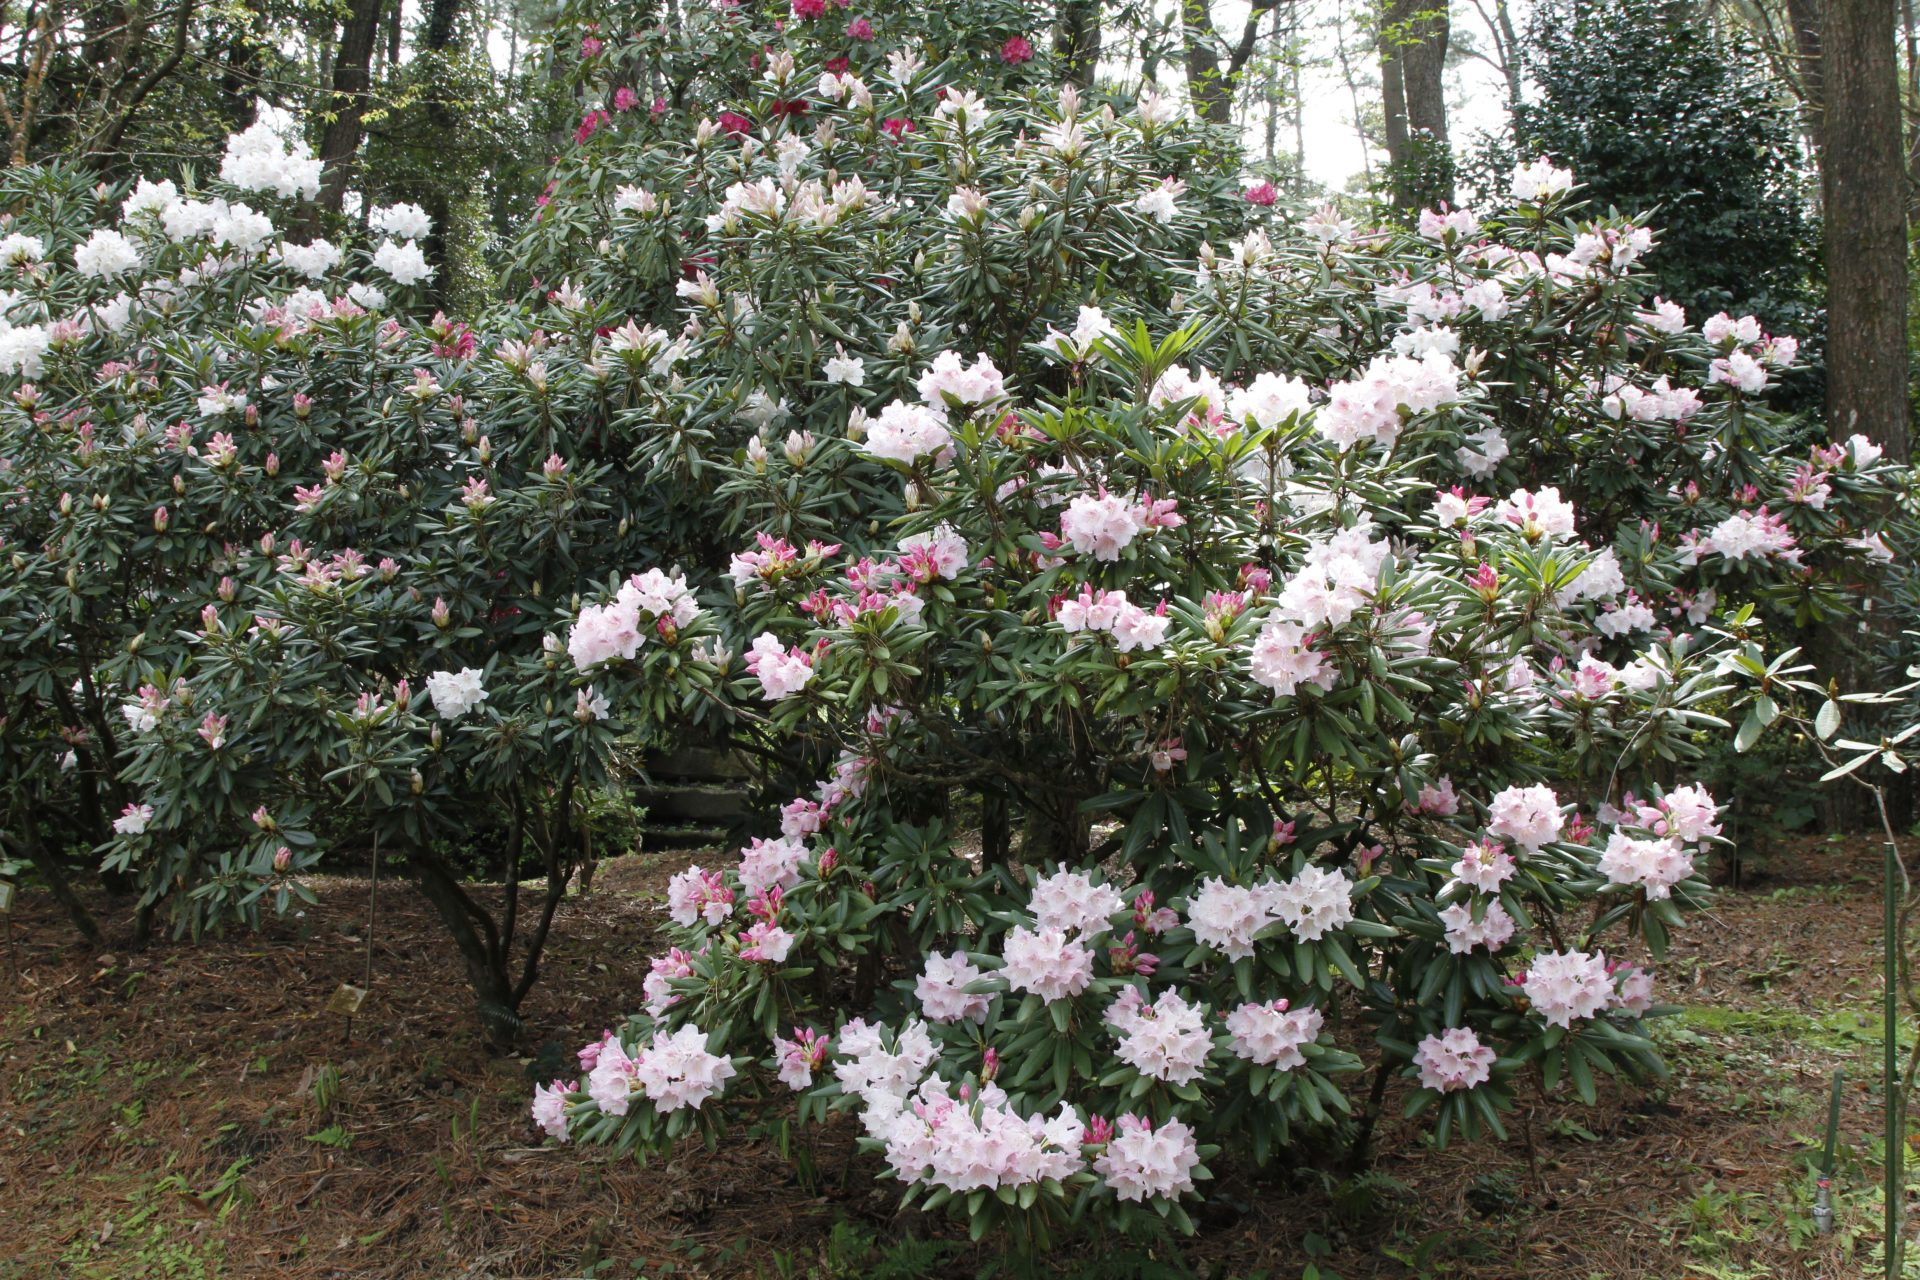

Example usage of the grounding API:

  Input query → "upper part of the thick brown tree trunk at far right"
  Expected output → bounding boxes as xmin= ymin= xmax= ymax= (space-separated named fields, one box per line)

xmin=1820 ymin=0 xmax=1908 ymax=462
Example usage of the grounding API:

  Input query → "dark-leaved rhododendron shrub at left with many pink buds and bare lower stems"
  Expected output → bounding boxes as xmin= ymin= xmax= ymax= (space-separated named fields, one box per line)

xmin=0 ymin=160 xmax=718 ymax=1034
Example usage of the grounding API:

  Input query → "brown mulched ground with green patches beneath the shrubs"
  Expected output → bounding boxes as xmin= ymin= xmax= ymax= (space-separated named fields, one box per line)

xmin=0 ymin=841 xmax=1912 ymax=1280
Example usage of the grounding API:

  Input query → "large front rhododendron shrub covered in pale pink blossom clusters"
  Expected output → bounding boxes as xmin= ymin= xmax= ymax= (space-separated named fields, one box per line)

xmin=518 ymin=192 xmax=1910 ymax=1240
